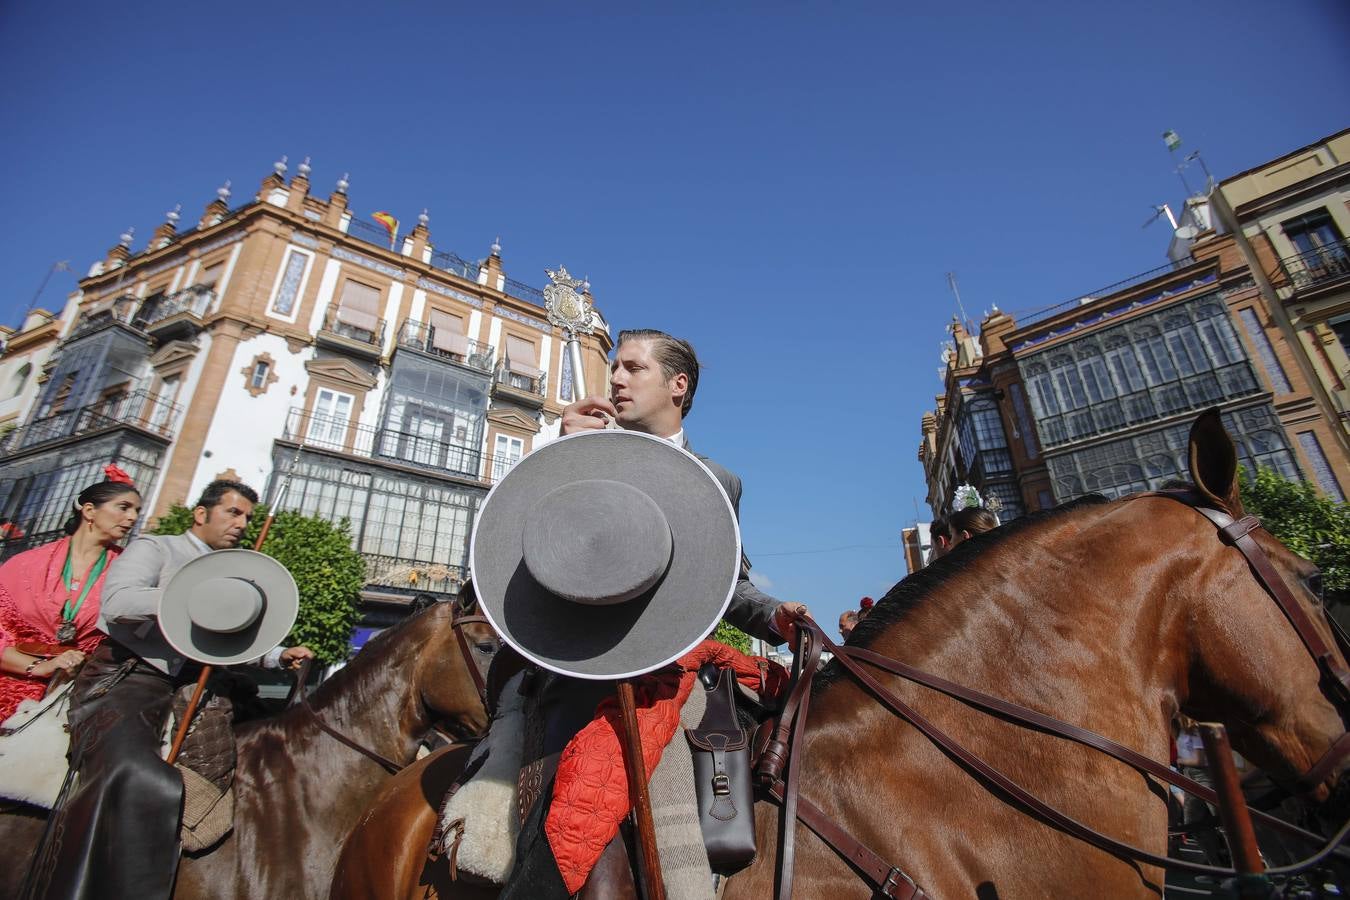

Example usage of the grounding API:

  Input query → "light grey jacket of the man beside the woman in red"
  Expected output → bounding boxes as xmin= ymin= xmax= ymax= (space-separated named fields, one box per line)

xmin=99 ymin=533 xmax=211 ymax=675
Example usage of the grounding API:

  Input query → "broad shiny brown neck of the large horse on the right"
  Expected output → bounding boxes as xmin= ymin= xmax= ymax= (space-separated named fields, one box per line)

xmin=821 ymin=503 xmax=1183 ymax=758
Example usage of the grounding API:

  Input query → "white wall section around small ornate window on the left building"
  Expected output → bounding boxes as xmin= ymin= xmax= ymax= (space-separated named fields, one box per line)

xmin=186 ymin=335 xmax=311 ymax=510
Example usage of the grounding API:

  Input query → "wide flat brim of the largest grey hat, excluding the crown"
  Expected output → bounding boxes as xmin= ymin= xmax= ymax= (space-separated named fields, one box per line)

xmin=470 ymin=430 xmax=741 ymax=680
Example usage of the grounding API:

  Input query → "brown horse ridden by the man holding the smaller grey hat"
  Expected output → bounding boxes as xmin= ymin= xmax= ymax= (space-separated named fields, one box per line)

xmin=0 ymin=603 xmax=497 ymax=900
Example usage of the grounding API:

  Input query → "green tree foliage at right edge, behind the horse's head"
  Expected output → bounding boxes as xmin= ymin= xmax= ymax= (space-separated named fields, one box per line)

xmin=1241 ymin=468 xmax=1350 ymax=600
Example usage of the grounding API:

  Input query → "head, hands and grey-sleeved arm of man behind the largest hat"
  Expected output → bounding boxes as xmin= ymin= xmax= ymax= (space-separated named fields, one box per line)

xmin=563 ymin=329 xmax=806 ymax=644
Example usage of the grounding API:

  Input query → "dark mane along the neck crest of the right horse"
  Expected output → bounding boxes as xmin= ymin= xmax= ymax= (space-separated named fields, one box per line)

xmin=818 ymin=494 xmax=1110 ymax=671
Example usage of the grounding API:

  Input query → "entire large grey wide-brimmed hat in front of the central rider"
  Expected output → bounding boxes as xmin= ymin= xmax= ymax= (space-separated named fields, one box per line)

xmin=470 ymin=430 xmax=741 ymax=679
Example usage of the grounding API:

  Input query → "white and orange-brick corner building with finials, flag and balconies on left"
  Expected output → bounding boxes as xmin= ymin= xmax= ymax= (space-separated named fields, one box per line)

xmin=0 ymin=161 xmax=612 ymax=615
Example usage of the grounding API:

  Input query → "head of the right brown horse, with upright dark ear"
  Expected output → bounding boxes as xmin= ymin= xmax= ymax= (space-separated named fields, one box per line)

xmin=1152 ymin=410 xmax=1350 ymax=801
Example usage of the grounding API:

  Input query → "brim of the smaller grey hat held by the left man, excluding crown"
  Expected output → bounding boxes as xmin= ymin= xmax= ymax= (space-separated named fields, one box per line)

xmin=159 ymin=549 xmax=300 ymax=665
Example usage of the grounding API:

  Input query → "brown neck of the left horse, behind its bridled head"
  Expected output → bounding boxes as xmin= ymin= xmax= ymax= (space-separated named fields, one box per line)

xmin=298 ymin=617 xmax=431 ymax=764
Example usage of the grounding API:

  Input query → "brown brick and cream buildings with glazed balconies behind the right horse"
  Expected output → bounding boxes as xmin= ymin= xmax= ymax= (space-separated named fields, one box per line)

xmin=919 ymin=131 xmax=1350 ymax=519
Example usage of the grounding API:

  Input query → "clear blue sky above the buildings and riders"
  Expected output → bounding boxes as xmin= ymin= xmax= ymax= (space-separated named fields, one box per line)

xmin=0 ymin=0 xmax=1350 ymax=634
